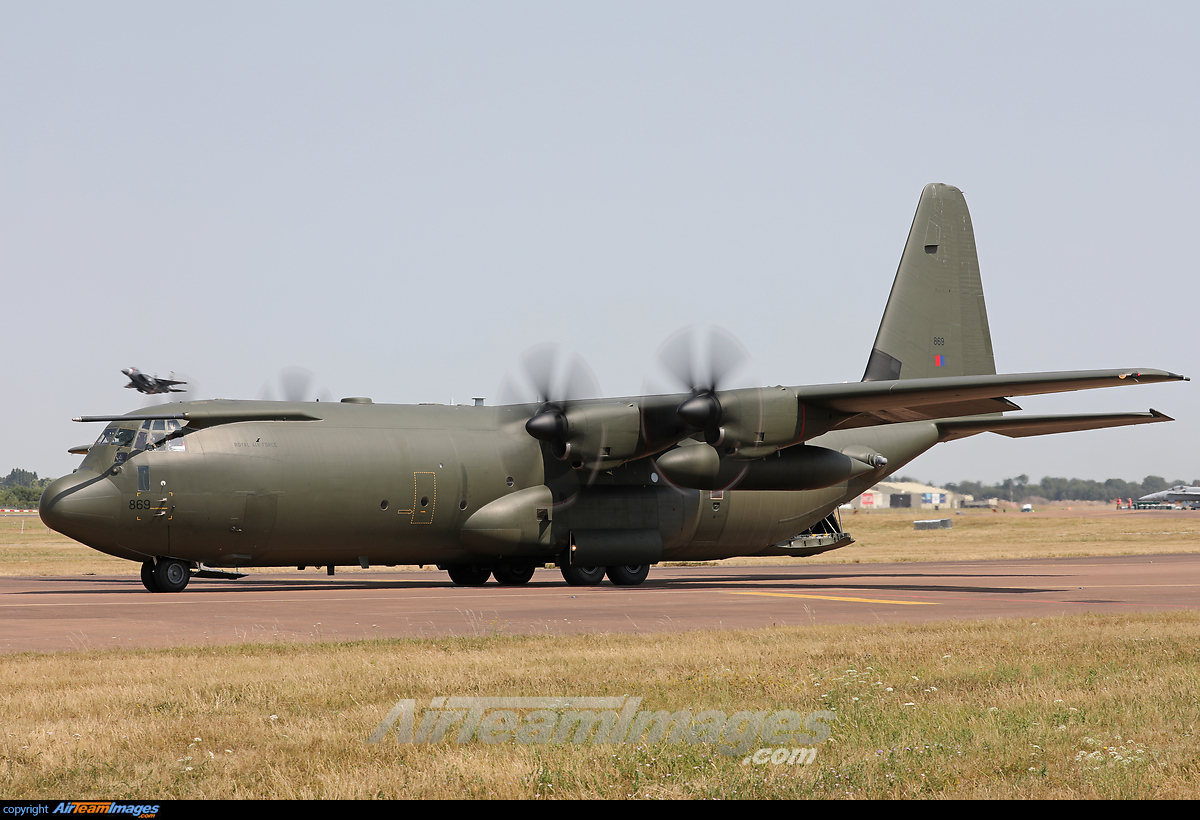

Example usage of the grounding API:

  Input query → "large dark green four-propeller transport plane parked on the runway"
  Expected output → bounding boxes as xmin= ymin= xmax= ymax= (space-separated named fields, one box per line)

xmin=41 ymin=185 xmax=1184 ymax=592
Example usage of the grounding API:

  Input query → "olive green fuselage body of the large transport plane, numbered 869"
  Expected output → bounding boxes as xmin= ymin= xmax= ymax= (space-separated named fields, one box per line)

xmin=43 ymin=403 xmax=937 ymax=567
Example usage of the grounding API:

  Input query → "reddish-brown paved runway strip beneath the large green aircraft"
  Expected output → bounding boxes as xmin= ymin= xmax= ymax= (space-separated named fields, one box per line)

xmin=0 ymin=555 xmax=1200 ymax=652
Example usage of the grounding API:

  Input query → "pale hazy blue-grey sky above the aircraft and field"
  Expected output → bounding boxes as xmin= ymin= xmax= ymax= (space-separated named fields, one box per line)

xmin=0 ymin=0 xmax=1200 ymax=481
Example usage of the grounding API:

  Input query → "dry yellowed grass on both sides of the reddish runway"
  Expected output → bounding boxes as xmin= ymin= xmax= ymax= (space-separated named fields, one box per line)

xmin=0 ymin=508 xmax=1200 ymax=800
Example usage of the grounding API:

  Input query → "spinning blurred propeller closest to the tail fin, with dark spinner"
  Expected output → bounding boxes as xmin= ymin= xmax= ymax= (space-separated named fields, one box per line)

xmin=659 ymin=327 xmax=750 ymax=447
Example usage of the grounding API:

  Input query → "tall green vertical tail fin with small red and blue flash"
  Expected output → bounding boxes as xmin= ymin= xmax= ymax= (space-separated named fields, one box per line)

xmin=863 ymin=182 xmax=996 ymax=382
